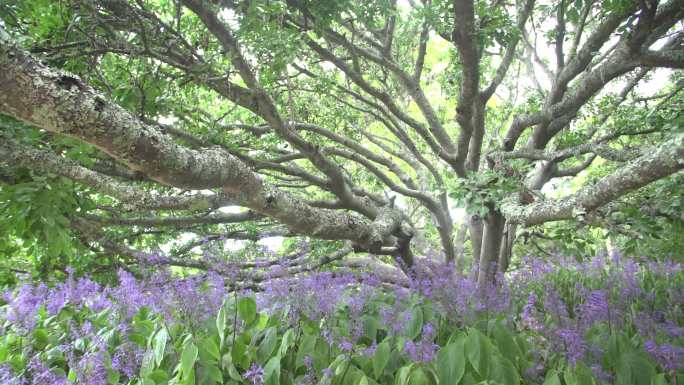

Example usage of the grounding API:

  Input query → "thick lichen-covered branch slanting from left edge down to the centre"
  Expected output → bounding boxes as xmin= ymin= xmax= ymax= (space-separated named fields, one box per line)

xmin=0 ymin=30 xmax=397 ymax=249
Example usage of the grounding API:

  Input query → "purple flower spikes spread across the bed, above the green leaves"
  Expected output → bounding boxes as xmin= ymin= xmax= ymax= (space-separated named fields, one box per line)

xmin=0 ymin=248 xmax=684 ymax=385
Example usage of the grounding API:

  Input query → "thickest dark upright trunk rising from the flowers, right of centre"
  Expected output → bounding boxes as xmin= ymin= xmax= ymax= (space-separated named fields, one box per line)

xmin=477 ymin=210 xmax=506 ymax=288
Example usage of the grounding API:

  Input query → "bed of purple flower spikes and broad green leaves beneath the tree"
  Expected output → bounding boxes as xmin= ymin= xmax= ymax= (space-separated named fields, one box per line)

xmin=0 ymin=254 xmax=684 ymax=385
